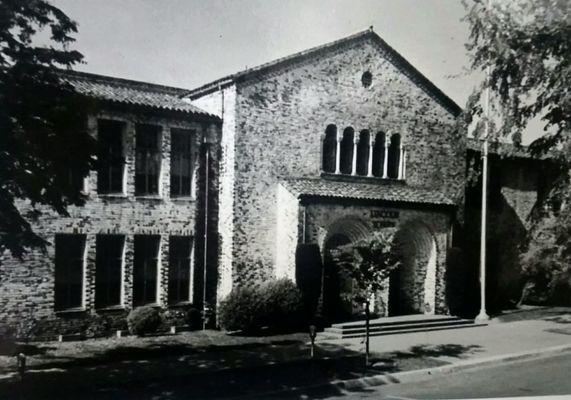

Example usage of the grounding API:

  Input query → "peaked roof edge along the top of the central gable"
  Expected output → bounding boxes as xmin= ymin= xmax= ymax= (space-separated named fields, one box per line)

xmin=186 ymin=27 xmax=462 ymax=116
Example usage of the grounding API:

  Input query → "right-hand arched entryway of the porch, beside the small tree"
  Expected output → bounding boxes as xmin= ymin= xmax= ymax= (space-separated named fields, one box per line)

xmin=389 ymin=221 xmax=437 ymax=315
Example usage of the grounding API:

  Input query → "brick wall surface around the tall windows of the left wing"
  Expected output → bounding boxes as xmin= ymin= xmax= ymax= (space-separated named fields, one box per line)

xmin=0 ymin=110 xmax=218 ymax=335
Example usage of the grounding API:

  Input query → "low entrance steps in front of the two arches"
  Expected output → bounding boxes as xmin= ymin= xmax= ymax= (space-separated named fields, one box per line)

xmin=323 ymin=314 xmax=486 ymax=339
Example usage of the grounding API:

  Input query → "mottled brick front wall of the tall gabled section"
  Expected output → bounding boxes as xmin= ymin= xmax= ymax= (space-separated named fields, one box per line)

xmin=233 ymin=36 xmax=465 ymax=284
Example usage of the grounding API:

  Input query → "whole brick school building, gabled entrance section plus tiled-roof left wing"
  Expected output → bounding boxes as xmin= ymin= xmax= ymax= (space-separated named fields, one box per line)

xmin=0 ymin=30 xmax=556 ymax=334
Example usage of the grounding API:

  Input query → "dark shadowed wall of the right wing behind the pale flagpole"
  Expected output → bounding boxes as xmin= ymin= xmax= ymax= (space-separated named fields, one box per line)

xmin=464 ymin=152 xmax=552 ymax=312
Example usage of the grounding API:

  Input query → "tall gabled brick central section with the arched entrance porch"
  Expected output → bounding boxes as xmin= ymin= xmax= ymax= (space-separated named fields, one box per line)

xmin=188 ymin=30 xmax=465 ymax=314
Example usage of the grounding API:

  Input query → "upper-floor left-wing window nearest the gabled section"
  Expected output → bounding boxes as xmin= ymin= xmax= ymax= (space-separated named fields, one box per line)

xmin=170 ymin=129 xmax=193 ymax=196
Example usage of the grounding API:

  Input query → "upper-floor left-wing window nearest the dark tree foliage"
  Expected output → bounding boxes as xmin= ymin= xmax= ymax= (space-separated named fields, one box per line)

xmin=97 ymin=120 xmax=125 ymax=193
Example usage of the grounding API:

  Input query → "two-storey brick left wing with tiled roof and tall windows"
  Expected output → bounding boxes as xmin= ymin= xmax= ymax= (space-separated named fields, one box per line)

xmin=0 ymin=73 xmax=221 ymax=337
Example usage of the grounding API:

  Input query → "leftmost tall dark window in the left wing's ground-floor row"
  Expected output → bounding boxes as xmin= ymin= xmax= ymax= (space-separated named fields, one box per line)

xmin=54 ymin=235 xmax=85 ymax=310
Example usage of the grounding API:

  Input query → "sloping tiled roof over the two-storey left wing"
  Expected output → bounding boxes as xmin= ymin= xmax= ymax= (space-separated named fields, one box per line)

xmin=59 ymin=70 xmax=218 ymax=119
